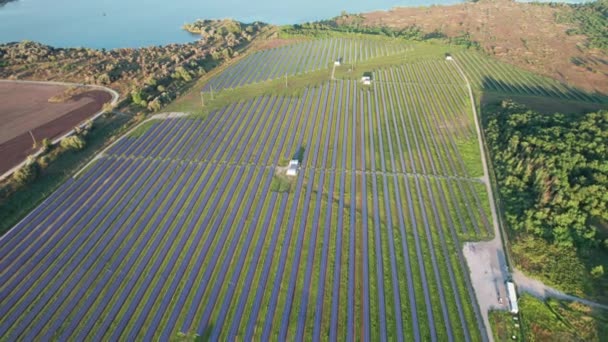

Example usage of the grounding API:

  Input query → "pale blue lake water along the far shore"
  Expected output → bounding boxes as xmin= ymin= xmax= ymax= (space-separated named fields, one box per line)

xmin=0 ymin=0 xmax=461 ymax=49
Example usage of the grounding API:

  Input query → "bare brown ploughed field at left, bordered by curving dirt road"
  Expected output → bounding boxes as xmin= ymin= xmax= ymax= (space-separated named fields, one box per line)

xmin=0 ymin=83 xmax=112 ymax=173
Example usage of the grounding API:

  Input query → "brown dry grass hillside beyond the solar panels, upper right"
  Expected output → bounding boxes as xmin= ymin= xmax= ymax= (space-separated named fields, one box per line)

xmin=363 ymin=0 xmax=608 ymax=94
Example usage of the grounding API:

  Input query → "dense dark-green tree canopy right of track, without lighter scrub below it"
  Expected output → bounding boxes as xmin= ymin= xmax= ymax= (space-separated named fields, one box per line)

xmin=484 ymin=101 xmax=608 ymax=248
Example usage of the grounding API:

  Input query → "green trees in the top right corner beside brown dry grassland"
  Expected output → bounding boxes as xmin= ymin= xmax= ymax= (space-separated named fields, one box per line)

xmin=552 ymin=0 xmax=608 ymax=51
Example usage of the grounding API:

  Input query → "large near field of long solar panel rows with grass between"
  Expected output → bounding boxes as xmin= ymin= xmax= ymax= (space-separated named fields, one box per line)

xmin=0 ymin=37 xmax=604 ymax=341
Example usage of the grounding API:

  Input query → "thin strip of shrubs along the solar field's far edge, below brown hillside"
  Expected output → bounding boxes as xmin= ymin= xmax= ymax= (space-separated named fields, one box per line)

xmin=281 ymin=13 xmax=479 ymax=49
